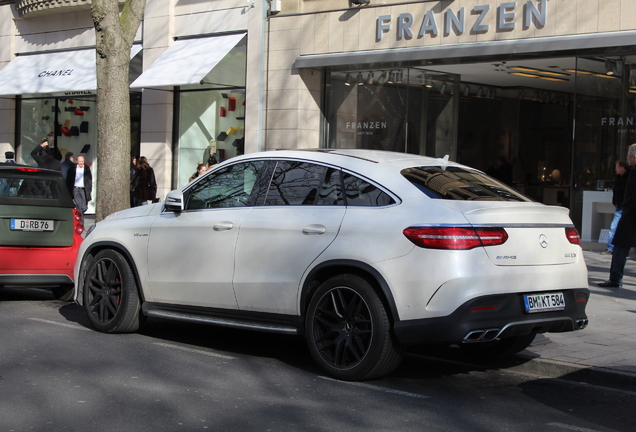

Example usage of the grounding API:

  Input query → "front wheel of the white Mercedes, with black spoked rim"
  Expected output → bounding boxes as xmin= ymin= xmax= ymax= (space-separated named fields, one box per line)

xmin=84 ymin=249 xmax=141 ymax=333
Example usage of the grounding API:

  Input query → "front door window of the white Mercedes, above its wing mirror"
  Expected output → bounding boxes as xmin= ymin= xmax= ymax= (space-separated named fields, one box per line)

xmin=185 ymin=161 xmax=265 ymax=210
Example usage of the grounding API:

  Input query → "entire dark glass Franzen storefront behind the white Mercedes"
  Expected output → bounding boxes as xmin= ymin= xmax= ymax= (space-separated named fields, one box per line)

xmin=323 ymin=53 xmax=636 ymax=239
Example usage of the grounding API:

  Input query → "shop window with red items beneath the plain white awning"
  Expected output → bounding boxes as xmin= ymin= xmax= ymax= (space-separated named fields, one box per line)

xmin=175 ymin=33 xmax=247 ymax=188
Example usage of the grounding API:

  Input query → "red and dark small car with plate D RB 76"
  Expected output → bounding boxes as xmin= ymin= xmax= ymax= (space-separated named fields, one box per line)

xmin=0 ymin=163 xmax=84 ymax=301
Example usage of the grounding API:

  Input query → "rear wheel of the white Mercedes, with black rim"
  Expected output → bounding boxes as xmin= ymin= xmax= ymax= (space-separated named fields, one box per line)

xmin=306 ymin=274 xmax=402 ymax=381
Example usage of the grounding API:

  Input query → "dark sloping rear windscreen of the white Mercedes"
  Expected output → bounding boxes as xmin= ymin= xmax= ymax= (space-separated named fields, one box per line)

xmin=402 ymin=166 xmax=531 ymax=201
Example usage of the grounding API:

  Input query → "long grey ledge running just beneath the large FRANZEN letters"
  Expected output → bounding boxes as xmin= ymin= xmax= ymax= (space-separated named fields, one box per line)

xmin=293 ymin=30 xmax=636 ymax=69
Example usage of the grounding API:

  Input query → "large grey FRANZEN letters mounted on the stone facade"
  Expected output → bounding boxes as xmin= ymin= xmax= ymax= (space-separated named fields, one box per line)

xmin=376 ymin=0 xmax=548 ymax=42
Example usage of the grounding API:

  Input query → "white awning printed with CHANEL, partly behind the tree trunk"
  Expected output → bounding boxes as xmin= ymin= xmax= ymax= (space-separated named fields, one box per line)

xmin=0 ymin=45 xmax=141 ymax=96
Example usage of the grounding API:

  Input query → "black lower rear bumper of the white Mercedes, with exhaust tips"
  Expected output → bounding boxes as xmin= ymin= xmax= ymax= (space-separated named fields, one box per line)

xmin=394 ymin=288 xmax=590 ymax=345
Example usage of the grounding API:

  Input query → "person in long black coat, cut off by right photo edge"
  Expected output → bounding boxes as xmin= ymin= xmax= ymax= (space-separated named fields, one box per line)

xmin=597 ymin=144 xmax=636 ymax=288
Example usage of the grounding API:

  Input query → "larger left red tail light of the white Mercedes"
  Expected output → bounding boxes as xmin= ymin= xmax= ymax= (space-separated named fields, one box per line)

xmin=403 ymin=227 xmax=508 ymax=250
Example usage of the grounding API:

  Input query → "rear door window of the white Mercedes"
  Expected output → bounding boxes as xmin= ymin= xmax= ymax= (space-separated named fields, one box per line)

xmin=265 ymin=161 xmax=329 ymax=206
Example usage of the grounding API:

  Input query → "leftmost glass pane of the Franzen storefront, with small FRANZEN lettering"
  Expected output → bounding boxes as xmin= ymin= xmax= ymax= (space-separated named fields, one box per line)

xmin=326 ymin=68 xmax=459 ymax=157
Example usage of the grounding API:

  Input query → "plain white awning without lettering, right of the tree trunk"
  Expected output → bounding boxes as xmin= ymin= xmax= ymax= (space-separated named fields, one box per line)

xmin=130 ymin=33 xmax=245 ymax=88
